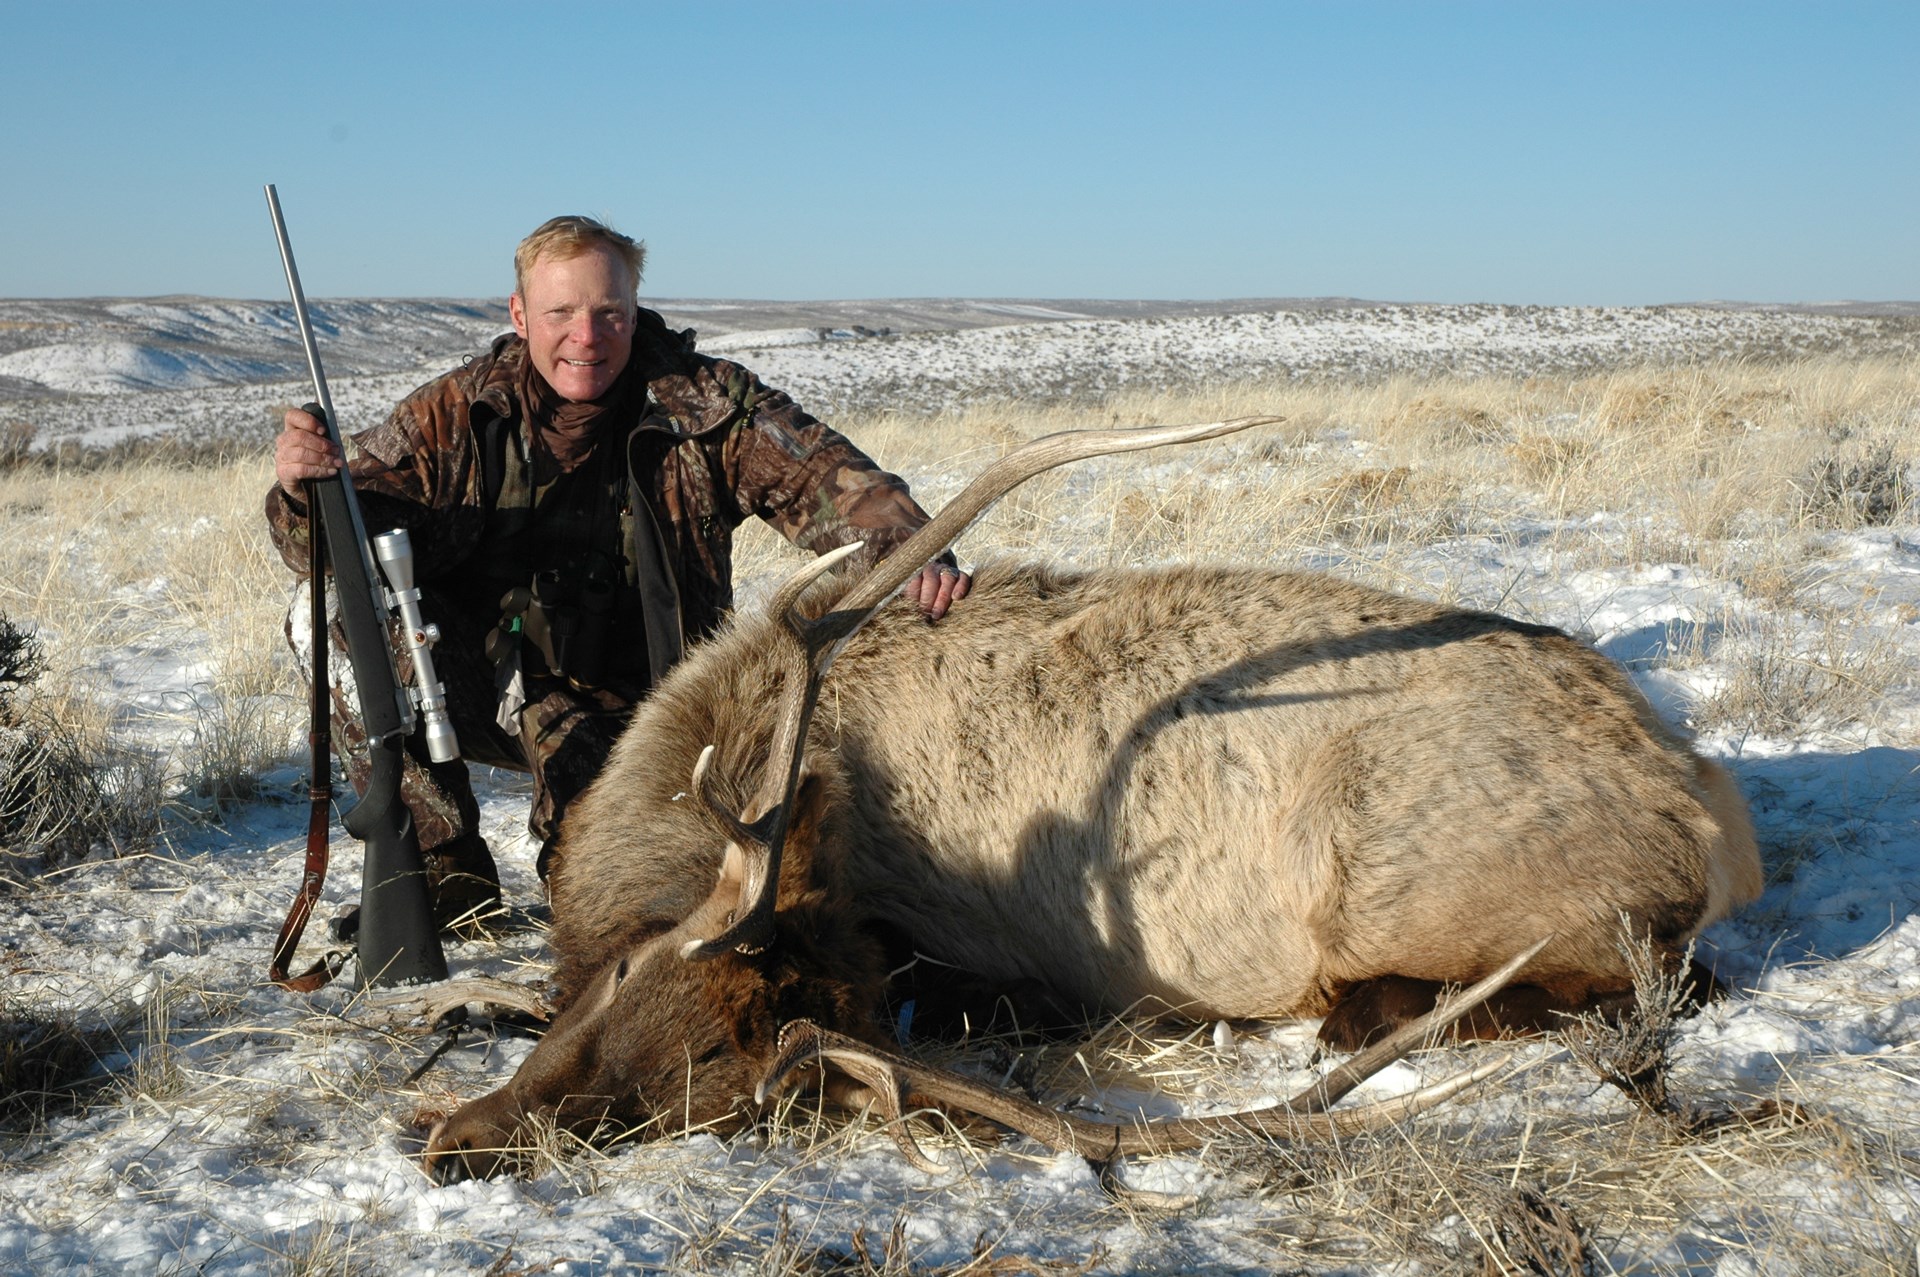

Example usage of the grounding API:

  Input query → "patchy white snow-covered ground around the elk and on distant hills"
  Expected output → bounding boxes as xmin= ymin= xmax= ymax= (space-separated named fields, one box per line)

xmin=0 ymin=301 xmax=1920 ymax=1275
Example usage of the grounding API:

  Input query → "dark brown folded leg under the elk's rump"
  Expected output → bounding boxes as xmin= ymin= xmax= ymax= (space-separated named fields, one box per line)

xmin=1319 ymin=960 xmax=1726 ymax=1050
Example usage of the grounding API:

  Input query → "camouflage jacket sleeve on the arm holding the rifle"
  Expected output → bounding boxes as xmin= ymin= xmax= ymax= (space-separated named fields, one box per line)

xmin=267 ymin=369 xmax=484 ymax=576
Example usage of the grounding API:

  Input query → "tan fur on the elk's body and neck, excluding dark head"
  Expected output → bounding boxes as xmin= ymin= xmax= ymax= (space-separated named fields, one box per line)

xmin=553 ymin=565 xmax=1759 ymax=1016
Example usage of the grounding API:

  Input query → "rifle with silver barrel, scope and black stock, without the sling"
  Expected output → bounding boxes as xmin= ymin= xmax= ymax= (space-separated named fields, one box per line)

xmin=267 ymin=184 xmax=455 ymax=985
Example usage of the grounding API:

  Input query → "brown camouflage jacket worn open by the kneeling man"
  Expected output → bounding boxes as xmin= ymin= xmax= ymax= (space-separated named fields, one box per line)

xmin=267 ymin=309 xmax=927 ymax=672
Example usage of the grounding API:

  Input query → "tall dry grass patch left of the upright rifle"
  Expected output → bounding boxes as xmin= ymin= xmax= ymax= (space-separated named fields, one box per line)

xmin=0 ymin=447 xmax=301 ymax=867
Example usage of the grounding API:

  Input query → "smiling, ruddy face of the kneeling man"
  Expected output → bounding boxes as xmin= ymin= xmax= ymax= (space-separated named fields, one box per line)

xmin=507 ymin=248 xmax=634 ymax=403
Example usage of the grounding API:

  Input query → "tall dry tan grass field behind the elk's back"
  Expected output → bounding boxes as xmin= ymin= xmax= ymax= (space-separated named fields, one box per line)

xmin=737 ymin=357 xmax=1920 ymax=629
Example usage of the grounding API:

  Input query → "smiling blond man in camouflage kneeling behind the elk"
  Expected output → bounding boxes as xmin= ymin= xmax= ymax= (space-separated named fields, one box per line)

xmin=267 ymin=217 xmax=970 ymax=924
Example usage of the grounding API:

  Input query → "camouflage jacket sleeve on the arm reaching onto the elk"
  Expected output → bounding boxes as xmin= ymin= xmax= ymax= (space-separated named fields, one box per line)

xmin=652 ymin=357 xmax=927 ymax=566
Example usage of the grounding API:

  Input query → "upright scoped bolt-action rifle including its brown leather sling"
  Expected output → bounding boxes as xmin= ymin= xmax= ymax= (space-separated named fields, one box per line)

xmin=267 ymin=184 xmax=459 ymax=991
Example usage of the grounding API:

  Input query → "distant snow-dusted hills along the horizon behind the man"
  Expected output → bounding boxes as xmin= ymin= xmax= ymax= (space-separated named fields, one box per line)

xmin=0 ymin=298 xmax=1920 ymax=446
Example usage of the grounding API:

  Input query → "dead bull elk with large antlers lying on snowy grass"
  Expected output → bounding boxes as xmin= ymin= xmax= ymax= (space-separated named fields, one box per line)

xmin=426 ymin=419 xmax=1761 ymax=1179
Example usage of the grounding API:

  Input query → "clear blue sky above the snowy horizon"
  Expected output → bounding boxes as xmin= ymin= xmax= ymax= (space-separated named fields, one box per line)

xmin=0 ymin=0 xmax=1920 ymax=303
